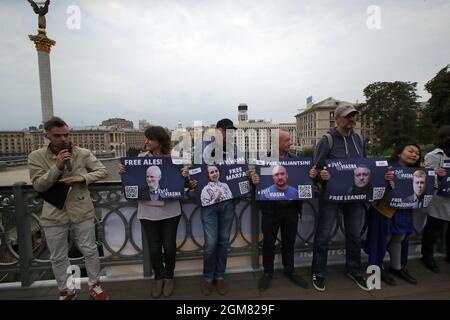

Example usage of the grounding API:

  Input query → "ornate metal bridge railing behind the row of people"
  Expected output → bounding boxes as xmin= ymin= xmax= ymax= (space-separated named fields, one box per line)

xmin=0 ymin=182 xmax=423 ymax=287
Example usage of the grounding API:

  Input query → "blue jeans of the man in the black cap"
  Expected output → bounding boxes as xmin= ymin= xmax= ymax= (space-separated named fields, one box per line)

xmin=202 ymin=200 xmax=234 ymax=281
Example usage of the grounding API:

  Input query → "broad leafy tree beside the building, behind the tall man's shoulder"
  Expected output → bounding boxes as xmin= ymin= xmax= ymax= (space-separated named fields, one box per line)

xmin=360 ymin=81 xmax=419 ymax=154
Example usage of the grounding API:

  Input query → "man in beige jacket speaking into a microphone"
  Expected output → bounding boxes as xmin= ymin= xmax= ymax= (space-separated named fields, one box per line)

xmin=28 ymin=117 xmax=108 ymax=300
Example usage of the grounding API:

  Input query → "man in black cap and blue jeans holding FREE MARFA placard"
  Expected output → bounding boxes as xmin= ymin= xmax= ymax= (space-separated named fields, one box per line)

xmin=193 ymin=119 xmax=244 ymax=296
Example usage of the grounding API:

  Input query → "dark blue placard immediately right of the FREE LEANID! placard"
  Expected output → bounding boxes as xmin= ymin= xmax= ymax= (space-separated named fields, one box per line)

xmin=389 ymin=168 xmax=435 ymax=209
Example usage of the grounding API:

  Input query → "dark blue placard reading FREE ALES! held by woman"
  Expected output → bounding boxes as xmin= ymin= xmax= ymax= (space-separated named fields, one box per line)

xmin=120 ymin=156 xmax=184 ymax=200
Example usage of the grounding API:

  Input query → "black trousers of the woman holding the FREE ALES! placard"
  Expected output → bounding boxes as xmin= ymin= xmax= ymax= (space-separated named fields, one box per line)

xmin=140 ymin=215 xmax=181 ymax=280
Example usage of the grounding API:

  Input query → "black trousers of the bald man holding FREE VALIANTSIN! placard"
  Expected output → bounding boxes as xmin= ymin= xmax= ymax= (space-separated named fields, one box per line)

xmin=262 ymin=202 xmax=298 ymax=274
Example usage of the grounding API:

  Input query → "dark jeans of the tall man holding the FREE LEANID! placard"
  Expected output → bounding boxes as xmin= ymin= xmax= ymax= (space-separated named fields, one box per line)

xmin=311 ymin=200 xmax=365 ymax=277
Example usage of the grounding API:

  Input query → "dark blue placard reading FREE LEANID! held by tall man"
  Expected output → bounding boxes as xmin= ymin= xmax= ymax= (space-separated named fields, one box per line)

xmin=325 ymin=158 xmax=388 ymax=202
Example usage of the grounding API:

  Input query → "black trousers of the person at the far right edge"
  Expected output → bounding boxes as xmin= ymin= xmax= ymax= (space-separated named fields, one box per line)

xmin=422 ymin=216 xmax=450 ymax=260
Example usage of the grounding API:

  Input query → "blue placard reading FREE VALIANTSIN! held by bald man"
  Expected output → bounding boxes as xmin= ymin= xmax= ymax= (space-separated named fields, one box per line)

xmin=256 ymin=157 xmax=313 ymax=201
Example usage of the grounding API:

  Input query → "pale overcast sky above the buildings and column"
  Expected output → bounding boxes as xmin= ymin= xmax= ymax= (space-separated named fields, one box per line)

xmin=0 ymin=0 xmax=450 ymax=130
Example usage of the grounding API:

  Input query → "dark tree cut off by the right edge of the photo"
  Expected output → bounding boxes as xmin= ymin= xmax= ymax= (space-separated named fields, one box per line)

xmin=425 ymin=65 xmax=450 ymax=128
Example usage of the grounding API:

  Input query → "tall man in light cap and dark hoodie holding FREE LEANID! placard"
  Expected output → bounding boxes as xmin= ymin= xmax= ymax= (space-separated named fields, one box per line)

xmin=310 ymin=103 xmax=369 ymax=291
